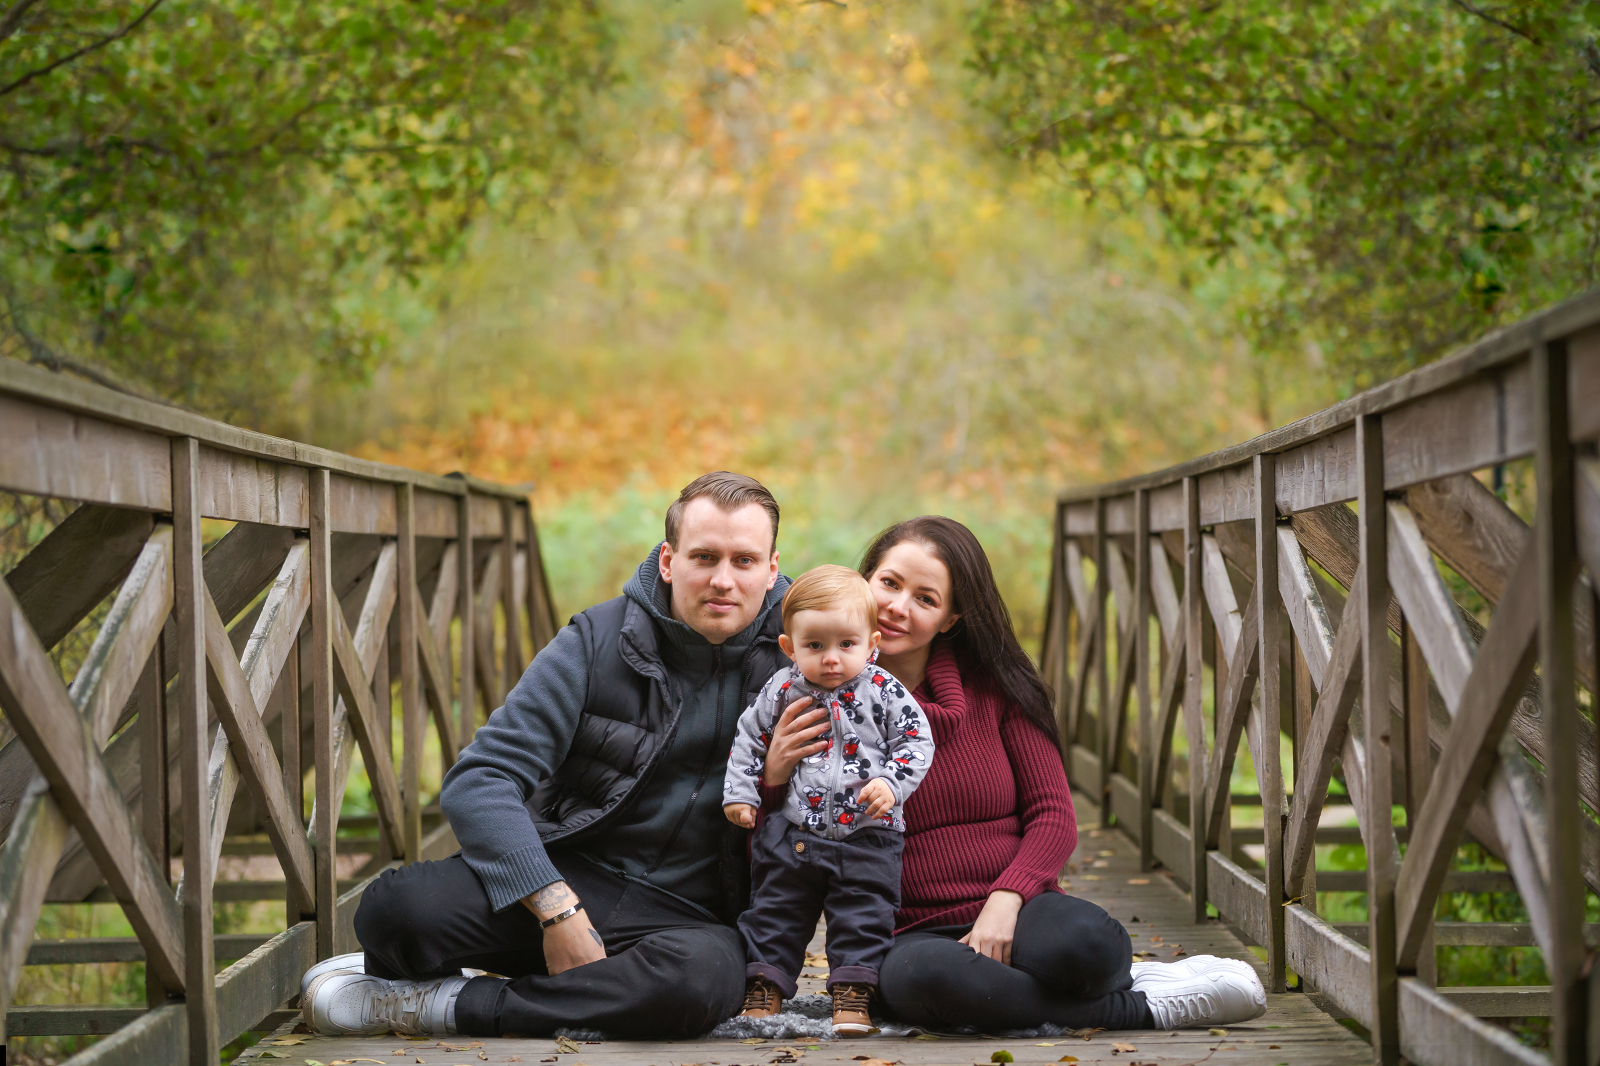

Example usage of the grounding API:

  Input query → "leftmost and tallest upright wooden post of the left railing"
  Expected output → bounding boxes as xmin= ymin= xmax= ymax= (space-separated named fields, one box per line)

xmin=173 ymin=437 xmax=218 ymax=1066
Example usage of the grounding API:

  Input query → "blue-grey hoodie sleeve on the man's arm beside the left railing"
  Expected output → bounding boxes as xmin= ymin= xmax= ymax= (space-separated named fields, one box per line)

xmin=438 ymin=626 xmax=589 ymax=911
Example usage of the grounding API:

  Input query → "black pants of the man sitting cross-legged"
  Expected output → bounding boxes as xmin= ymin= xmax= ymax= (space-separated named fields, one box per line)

xmin=355 ymin=853 xmax=744 ymax=1039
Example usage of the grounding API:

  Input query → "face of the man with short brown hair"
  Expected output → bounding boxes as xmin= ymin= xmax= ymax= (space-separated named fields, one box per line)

xmin=661 ymin=496 xmax=778 ymax=643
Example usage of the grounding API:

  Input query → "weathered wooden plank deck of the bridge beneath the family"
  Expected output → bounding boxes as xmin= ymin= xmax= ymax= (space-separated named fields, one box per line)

xmin=238 ymin=806 xmax=1371 ymax=1066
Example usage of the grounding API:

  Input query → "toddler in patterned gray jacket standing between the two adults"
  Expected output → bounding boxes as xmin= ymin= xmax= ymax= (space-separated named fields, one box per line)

xmin=722 ymin=567 xmax=933 ymax=1036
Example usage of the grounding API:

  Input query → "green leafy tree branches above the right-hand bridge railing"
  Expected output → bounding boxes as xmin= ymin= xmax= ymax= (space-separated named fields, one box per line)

xmin=971 ymin=0 xmax=1600 ymax=387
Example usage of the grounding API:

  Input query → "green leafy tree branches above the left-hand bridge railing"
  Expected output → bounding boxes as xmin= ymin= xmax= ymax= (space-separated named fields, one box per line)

xmin=0 ymin=0 xmax=613 ymax=424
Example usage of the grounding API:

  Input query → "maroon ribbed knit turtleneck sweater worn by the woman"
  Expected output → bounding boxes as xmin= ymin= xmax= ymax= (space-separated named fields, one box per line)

xmin=894 ymin=642 xmax=1078 ymax=932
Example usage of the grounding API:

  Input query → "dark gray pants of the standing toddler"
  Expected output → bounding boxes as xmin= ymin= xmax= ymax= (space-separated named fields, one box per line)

xmin=739 ymin=813 xmax=906 ymax=999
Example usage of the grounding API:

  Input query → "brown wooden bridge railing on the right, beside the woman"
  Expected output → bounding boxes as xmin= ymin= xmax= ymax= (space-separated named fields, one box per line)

xmin=1042 ymin=286 xmax=1600 ymax=1066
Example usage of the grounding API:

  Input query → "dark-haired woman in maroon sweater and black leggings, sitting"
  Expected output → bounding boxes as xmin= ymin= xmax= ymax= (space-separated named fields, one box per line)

xmin=766 ymin=515 xmax=1266 ymax=1031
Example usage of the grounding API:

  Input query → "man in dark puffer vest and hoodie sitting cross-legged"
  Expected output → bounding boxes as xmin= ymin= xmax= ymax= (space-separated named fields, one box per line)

xmin=302 ymin=472 xmax=826 ymax=1037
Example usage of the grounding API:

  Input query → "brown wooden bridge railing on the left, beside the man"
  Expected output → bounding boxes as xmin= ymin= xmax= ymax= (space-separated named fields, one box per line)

xmin=0 ymin=360 xmax=555 ymax=1066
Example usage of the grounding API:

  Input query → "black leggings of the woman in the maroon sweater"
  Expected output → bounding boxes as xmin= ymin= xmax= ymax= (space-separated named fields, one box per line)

xmin=878 ymin=892 xmax=1155 ymax=1032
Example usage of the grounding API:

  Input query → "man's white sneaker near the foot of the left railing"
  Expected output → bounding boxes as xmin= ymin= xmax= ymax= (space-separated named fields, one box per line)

xmin=301 ymin=972 xmax=467 ymax=1036
